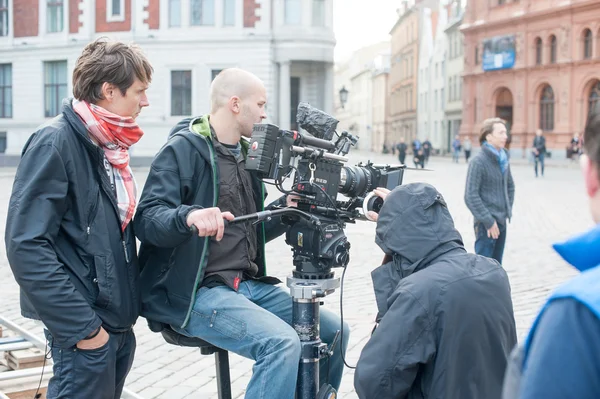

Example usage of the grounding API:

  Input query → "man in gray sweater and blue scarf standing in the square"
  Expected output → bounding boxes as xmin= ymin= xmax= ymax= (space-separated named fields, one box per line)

xmin=465 ymin=118 xmax=515 ymax=264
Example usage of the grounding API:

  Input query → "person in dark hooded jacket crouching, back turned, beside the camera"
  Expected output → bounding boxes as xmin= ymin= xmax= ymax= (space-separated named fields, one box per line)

xmin=354 ymin=183 xmax=517 ymax=399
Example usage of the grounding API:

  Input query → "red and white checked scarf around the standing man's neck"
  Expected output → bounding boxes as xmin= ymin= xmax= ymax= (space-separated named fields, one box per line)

xmin=73 ymin=100 xmax=144 ymax=231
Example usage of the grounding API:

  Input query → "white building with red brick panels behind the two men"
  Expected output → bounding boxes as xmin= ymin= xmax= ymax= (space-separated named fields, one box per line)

xmin=0 ymin=0 xmax=335 ymax=164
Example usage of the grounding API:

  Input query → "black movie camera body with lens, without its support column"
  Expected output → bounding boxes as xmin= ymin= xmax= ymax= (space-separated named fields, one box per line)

xmin=246 ymin=103 xmax=404 ymax=279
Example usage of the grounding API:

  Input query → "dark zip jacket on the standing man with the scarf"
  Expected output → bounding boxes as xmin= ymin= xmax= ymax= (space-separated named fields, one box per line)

xmin=5 ymin=100 xmax=139 ymax=348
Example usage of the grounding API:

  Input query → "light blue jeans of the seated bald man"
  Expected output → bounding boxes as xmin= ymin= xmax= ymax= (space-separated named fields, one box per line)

xmin=173 ymin=280 xmax=350 ymax=399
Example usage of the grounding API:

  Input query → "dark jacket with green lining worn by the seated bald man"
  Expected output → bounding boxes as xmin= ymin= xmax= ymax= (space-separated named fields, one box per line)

xmin=134 ymin=116 xmax=287 ymax=331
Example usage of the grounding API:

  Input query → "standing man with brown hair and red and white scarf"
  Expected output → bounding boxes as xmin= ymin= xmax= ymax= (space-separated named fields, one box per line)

xmin=5 ymin=39 xmax=153 ymax=399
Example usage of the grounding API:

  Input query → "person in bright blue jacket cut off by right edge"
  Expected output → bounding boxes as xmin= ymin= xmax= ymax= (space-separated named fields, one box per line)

xmin=503 ymin=113 xmax=600 ymax=399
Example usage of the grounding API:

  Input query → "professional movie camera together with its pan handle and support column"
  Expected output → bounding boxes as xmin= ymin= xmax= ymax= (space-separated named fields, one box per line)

xmin=229 ymin=103 xmax=405 ymax=399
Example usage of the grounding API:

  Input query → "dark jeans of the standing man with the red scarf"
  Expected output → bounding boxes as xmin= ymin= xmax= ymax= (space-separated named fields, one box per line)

xmin=45 ymin=330 xmax=136 ymax=399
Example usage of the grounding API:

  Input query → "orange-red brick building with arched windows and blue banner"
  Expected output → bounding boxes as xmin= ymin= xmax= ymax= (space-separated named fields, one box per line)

xmin=460 ymin=0 xmax=600 ymax=158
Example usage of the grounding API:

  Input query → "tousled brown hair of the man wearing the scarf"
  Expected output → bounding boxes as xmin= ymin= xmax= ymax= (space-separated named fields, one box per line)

xmin=73 ymin=37 xmax=154 ymax=104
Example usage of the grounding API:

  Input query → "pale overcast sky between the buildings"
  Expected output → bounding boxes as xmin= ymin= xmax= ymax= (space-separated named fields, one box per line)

xmin=333 ymin=0 xmax=402 ymax=61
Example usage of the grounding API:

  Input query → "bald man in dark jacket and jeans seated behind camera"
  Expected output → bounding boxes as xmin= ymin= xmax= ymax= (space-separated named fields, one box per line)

xmin=134 ymin=68 xmax=349 ymax=399
